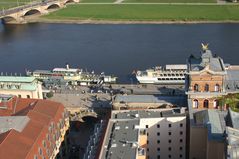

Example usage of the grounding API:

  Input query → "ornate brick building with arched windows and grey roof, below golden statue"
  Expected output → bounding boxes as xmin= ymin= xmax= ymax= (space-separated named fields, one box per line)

xmin=186 ymin=48 xmax=227 ymax=109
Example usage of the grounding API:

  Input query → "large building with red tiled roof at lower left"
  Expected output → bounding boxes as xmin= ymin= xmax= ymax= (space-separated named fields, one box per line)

xmin=0 ymin=95 xmax=69 ymax=159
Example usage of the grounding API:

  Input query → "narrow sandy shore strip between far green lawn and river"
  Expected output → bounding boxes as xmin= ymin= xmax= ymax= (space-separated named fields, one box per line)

xmin=28 ymin=18 xmax=239 ymax=24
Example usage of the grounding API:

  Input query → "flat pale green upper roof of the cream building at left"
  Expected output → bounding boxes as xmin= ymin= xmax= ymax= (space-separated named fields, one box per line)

xmin=0 ymin=76 xmax=36 ymax=83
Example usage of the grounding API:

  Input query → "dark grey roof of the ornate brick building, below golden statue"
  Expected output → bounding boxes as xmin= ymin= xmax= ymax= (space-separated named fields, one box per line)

xmin=188 ymin=50 xmax=225 ymax=72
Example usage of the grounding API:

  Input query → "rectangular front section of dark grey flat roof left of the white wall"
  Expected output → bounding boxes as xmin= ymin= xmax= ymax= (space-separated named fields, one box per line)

xmin=102 ymin=119 xmax=139 ymax=159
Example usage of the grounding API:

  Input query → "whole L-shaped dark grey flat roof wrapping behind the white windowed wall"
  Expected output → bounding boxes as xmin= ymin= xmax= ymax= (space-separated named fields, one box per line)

xmin=101 ymin=109 xmax=185 ymax=159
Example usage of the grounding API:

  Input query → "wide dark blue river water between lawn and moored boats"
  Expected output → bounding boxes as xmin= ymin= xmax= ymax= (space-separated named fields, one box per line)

xmin=0 ymin=23 xmax=239 ymax=82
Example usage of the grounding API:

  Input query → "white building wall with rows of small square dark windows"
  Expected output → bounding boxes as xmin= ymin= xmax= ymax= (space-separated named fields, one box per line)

xmin=140 ymin=116 xmax=186 ymax=159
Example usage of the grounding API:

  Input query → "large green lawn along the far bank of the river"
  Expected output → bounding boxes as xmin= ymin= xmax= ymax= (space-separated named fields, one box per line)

xmin=45 ymin=4 xmax=239 ymax=21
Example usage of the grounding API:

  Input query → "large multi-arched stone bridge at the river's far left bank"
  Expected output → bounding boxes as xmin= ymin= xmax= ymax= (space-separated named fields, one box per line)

xmin=0 ymin=0 xmax=79 ymax=24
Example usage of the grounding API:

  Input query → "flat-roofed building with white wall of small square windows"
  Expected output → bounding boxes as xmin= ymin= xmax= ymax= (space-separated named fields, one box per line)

xmin=99 ymin=109 xmax=186 ymax=159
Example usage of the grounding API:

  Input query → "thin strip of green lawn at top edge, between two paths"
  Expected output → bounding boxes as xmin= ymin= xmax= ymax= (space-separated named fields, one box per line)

xmin=123 ymin=0 xmax=216 ymax=3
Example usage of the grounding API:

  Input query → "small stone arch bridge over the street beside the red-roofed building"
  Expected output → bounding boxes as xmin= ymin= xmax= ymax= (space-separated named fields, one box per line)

xmin=66 ymin=107 xmax=98 ymax=122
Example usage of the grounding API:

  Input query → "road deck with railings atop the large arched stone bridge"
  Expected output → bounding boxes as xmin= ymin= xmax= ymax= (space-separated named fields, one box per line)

xmin=0 ymin=0 xmax=62 ymax=17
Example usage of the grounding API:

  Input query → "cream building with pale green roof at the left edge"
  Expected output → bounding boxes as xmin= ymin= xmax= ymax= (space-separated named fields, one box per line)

xmin=0 ymin=76 xmax=43 ymax=99
